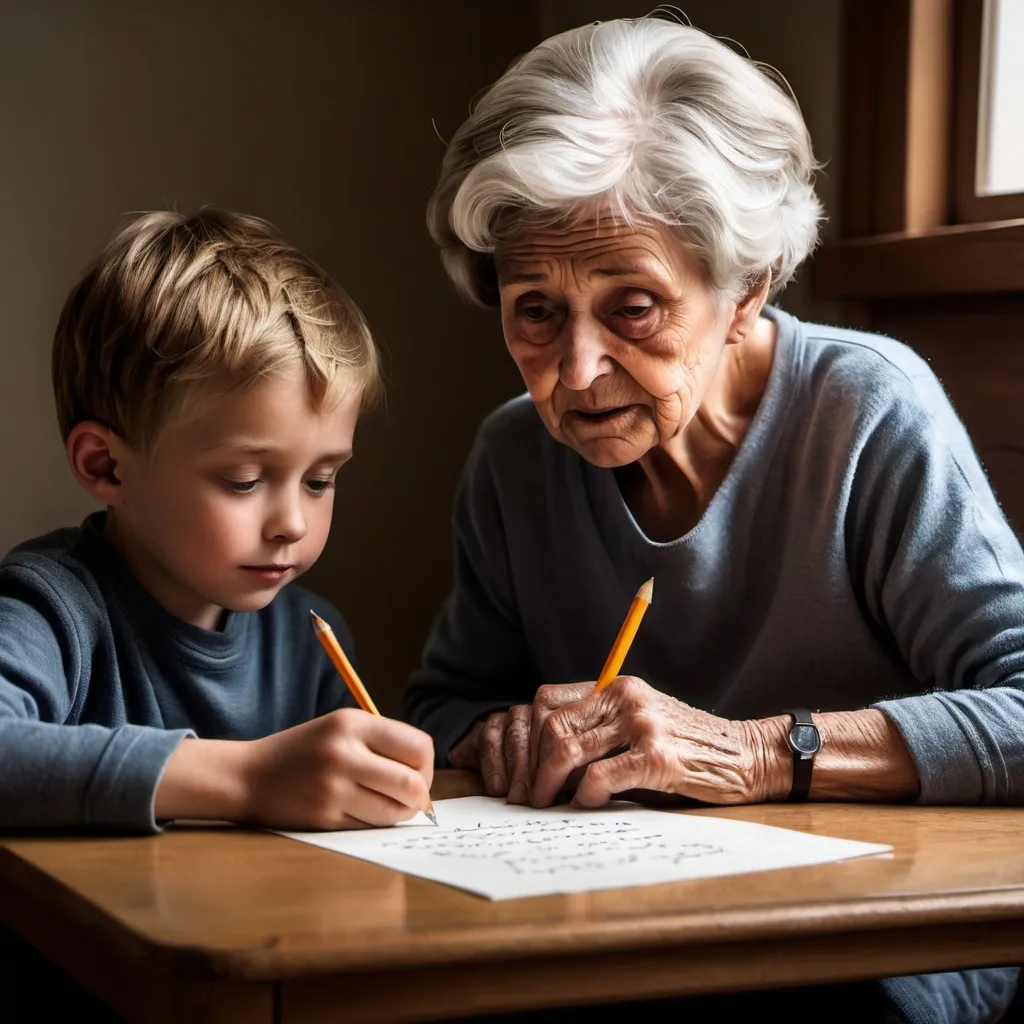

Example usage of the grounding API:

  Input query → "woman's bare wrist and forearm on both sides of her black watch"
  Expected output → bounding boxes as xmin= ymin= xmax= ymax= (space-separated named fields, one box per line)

xmin=754 ymin=709 xmax=921 ymax=803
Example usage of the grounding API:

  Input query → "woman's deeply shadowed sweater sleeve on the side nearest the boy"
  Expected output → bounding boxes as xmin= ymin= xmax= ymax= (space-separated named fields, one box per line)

xmin=403 ymin=439 xmax=541 ymax=767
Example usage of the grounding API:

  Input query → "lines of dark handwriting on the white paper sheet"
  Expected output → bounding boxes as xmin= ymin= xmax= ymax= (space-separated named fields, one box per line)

xmin=382 ymin=818 xmax=724 ymax=874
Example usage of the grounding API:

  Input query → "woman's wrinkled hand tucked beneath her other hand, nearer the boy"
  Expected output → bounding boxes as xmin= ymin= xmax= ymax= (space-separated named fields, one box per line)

xmin=449 ymin=683 xmax=594 ymax=804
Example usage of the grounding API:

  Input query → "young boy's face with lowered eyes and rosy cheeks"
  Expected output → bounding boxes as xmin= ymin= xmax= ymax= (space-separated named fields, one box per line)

xmin=108 ymin=367 xmax=359 ymax=629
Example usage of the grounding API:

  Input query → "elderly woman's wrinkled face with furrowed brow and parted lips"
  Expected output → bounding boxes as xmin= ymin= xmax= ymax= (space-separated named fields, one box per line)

xmin=496 ymin=218 xmax=756 ymax=467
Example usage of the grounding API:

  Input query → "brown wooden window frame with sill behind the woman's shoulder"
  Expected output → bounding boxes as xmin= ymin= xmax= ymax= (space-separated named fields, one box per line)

xmin=812 ymin=0 xmax=1024 ymax=300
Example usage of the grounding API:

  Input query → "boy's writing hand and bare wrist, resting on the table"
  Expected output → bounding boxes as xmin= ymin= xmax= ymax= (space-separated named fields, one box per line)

xmin=156 ymin=708 xmax=434 ymax=830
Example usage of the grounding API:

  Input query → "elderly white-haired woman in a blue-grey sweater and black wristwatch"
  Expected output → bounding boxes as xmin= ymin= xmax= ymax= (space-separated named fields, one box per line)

xmin=407 ymin=18 xmax=1024 ymax=1022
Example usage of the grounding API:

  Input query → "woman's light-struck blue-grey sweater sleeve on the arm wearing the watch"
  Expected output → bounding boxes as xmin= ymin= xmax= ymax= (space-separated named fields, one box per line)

xmin=848 ymin=369 xmax=1024 ymax=804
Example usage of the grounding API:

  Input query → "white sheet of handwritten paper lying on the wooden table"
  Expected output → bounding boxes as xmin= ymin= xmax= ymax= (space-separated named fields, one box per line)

xmin=280 ymin=797 xmax=892 ymax=900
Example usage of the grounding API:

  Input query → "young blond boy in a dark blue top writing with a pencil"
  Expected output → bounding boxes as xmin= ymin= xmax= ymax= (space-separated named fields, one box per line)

xmin=0 ymin=210 xmax=433 ymax=831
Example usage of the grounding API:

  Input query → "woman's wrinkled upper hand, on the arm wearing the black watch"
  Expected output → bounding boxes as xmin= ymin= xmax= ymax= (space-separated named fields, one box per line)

xmin=531 ymin=676 xmax=774 ymax=807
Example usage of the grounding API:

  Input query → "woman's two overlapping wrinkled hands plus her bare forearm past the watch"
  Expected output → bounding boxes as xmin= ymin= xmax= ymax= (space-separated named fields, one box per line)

xmin=450 ymin=676 xmax=921 ymax=807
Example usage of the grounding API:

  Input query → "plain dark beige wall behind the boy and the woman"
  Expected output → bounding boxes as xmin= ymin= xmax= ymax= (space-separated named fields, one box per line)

xmin=0 ymin=0 xmax=840 ymax=711
